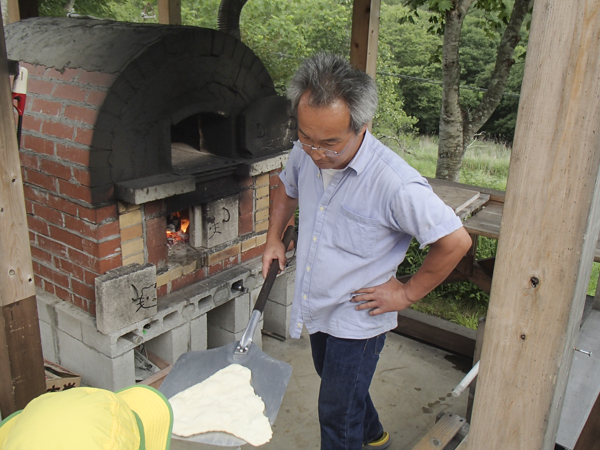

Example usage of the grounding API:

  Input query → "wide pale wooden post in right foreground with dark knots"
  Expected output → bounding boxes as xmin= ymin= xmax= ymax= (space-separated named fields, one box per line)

xmin=468 ymin=0 xmax=600 ymax=450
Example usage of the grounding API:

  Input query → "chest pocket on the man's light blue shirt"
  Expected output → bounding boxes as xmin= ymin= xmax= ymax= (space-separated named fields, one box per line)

xmin=333 ymin=205 xmax=379 ymax=258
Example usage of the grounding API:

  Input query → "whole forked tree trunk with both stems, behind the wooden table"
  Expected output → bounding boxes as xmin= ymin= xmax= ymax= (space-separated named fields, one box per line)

xmin=435 ymin=0 xmax=534 ymax=181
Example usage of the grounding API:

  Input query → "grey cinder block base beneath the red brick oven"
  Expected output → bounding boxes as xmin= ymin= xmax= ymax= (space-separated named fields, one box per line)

xmin=36 ymin=258 xmax=294 ymax=391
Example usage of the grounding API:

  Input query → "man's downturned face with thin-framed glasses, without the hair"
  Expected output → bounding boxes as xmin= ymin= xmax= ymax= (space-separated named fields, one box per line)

xmin=298 ymin=93 xmax=366 ymax=169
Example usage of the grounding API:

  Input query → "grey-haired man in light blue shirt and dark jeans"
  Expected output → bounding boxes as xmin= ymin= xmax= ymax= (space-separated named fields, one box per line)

xmin=263 ymin=54 xmax=471 ymax=450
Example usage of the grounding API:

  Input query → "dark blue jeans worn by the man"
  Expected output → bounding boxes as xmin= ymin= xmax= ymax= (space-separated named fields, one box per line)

xmin=310 ymin=333 xmax=385 ymax=450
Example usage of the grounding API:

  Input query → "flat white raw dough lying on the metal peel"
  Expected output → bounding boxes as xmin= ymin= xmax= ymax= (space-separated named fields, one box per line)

xmin=169 ymin=364 xmax=273 ymax=446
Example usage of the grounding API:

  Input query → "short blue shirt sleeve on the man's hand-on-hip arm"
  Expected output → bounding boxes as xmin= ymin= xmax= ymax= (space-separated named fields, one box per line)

xmin=391 ymin=177 xmax=462 ymax=248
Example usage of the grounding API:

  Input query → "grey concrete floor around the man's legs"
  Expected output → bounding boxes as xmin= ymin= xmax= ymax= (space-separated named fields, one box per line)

xmin=171 ymin=333 xmax=471 ymax=450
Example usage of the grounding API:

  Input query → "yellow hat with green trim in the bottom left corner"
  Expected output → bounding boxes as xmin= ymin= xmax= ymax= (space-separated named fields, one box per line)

xmin=0 ymin=385 xmax=173 ymax=450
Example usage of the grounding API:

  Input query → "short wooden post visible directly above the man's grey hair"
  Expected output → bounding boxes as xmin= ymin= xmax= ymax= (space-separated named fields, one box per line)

xmin=350 ymin=0 xmax=381 ymax=79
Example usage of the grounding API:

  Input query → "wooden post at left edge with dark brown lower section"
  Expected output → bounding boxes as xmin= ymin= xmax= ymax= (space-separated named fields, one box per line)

xmin=0 ymin=7 xmax=46 ymax=417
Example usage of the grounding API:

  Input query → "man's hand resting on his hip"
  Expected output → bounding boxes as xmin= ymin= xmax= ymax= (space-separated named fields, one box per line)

xmin=352 ymin=277 xmax=418 ymax=316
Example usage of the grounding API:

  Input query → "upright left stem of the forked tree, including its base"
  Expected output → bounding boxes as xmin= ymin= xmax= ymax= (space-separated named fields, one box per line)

xmin=435 ymin=0 xmax=473 ymax=181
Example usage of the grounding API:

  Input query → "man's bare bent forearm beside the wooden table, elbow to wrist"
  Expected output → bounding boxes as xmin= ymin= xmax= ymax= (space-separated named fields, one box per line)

xmin=404 ymin=228 xmax=471 ymax=303
